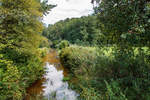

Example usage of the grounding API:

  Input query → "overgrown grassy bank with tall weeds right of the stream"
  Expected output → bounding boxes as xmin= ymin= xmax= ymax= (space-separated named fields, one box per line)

xmin=60 ymin=46 xmax=150 ymax=100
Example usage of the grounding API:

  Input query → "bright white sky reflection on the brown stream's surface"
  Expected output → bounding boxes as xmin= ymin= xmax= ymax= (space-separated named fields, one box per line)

xmin=43 ymin=63 xmax=78 ymax=100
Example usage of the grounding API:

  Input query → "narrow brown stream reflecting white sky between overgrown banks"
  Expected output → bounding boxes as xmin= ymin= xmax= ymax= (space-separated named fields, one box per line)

xmin=25 ymin=50 xmax=78 ymax=100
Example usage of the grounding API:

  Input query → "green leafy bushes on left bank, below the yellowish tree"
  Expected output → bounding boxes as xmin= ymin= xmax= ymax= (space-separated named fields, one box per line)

xmin=0 ymin=44 xmax=44 ymax=100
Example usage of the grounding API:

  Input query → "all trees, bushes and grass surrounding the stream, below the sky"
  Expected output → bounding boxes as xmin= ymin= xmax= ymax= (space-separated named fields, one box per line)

xmin=0 ymin=0 xmax=150 ymax=100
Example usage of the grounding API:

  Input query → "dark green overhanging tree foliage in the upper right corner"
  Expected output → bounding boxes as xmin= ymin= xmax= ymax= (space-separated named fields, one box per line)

xmin=98 ymin=0 xmax=150 ymax=46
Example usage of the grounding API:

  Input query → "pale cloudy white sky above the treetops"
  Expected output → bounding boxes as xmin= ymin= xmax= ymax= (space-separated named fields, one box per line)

xmin=43 ymin=0 xmax=93 ymax=25
